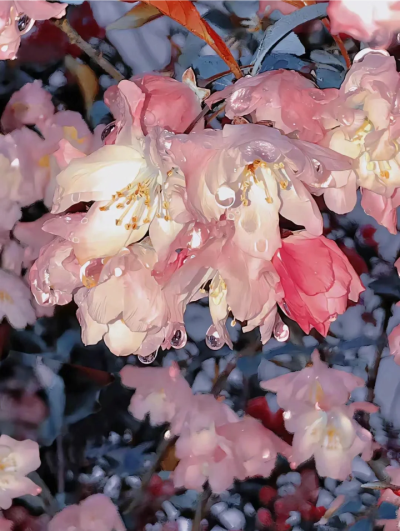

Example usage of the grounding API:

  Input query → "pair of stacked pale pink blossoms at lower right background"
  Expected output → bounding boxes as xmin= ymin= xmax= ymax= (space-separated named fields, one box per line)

xmin=261 ymin=351 xmax=378 ymax=480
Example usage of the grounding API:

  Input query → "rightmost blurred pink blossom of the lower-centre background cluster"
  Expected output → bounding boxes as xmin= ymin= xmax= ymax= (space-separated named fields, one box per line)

xmin=217 ymin=417 xmax=292 ymax=480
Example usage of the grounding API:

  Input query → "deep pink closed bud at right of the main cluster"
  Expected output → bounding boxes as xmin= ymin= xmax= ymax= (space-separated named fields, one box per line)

xmin=272 ymin=231 xmax=364 ymax=336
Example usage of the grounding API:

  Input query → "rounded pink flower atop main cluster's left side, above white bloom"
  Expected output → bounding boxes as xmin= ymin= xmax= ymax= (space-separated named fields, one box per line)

xmin=104 ymin=74 xmax=201 ymax=135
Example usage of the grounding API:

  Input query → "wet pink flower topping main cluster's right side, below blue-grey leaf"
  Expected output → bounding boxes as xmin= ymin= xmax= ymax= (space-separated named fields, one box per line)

xmin=207 ymin=72 xmax=339 ymax=142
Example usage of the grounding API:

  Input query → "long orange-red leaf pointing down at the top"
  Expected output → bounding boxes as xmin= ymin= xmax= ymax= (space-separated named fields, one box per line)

xmin=122 ymin=0 xmax=243 ymax=79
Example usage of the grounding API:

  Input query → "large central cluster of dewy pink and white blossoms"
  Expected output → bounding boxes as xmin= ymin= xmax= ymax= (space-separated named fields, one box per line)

xmin=30 ymin=66 xmax=376 ymax=361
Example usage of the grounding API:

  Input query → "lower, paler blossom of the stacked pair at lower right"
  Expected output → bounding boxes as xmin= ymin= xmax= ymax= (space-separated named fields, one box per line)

xmin=285 ymin=402 xmax=378 ymax=481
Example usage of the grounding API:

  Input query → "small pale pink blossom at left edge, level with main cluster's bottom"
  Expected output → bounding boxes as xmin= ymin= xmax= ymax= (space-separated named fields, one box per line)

xmin=0 ymin=269 xmax=36 ymax=328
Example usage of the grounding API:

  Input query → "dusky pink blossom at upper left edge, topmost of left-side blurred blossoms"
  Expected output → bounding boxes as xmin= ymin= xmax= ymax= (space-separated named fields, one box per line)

xmin=1 ymin=80 xmax=54 ymax=132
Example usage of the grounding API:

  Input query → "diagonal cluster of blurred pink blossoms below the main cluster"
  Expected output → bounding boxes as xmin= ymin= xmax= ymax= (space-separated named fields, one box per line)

xmin=121 ymin=365 xmax=292 ymax=493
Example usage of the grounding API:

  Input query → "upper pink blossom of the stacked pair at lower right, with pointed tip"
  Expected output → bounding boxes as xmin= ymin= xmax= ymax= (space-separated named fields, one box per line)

xmin=260 ymin=350 xmax=365 ymax=417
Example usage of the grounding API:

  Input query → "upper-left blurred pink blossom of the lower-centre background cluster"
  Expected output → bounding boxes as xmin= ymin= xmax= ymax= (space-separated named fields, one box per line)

xmin=120 ymin=365 xmax=193 ymax=435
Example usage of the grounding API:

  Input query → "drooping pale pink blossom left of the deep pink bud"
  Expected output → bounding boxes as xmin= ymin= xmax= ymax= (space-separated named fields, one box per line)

xmin=153 ymin=220 xmax=280 ymax=347
